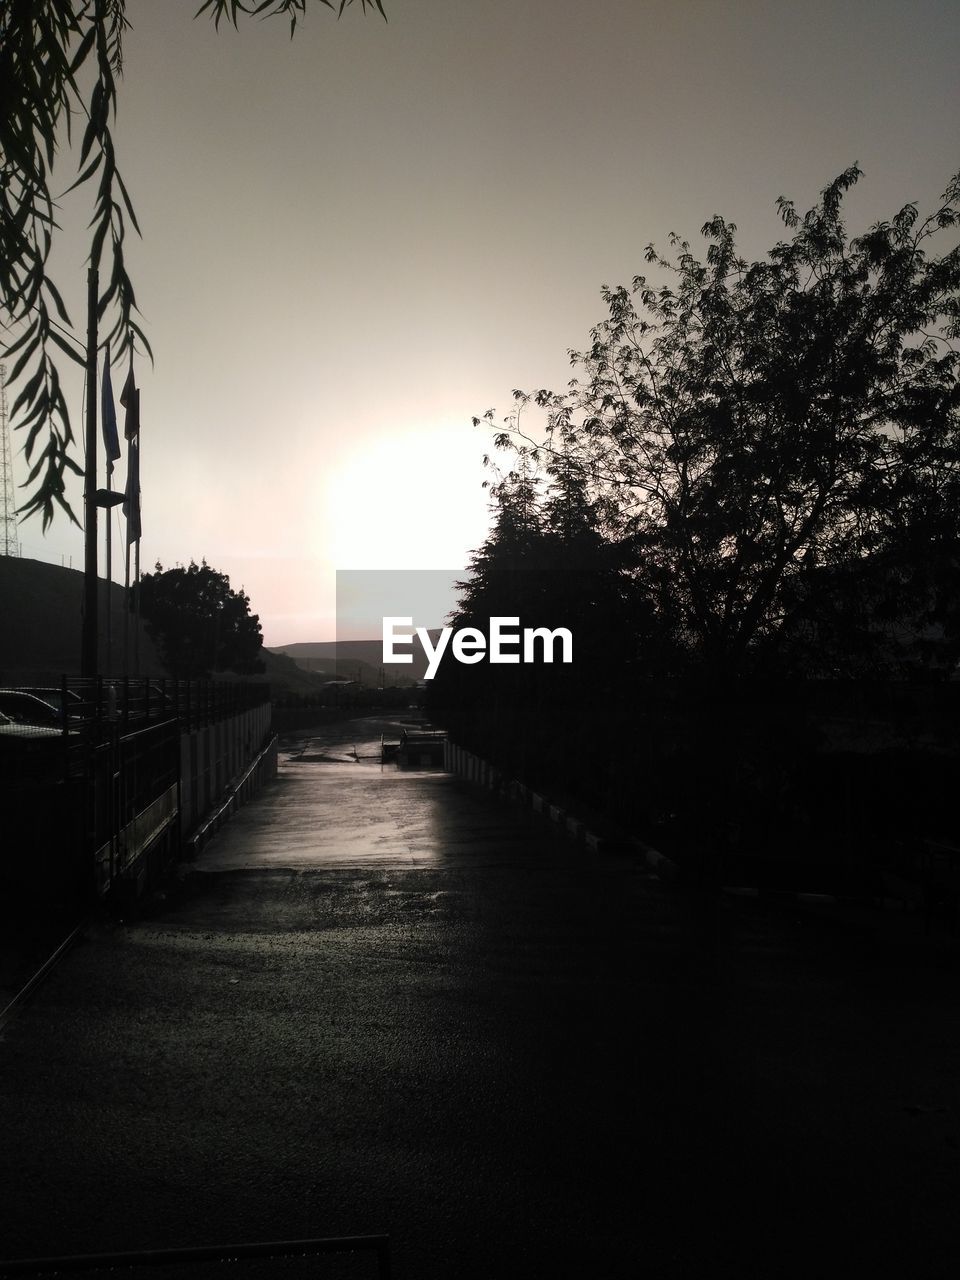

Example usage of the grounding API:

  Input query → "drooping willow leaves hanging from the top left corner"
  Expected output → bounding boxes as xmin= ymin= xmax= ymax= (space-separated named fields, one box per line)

xmin=0 ymin=0 xmax=385 ymax=530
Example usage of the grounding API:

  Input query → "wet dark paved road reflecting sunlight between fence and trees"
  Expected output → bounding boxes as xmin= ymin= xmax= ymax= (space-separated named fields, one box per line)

xmin=0 ymin=724 xmax=960 ymax=1280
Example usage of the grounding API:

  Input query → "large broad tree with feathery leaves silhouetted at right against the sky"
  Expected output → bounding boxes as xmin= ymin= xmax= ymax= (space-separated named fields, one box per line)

xmin=486 ymin=166 xmax=960 ymax=676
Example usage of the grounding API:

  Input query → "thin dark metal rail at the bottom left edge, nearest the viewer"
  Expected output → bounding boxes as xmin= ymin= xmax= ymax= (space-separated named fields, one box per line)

xmin=0 ymin=1235 xmax=390 ymax=1280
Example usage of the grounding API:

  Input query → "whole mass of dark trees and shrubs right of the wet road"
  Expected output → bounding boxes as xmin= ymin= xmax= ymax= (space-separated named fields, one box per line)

xmin=429 ymin=169 xmax=960 ymax=891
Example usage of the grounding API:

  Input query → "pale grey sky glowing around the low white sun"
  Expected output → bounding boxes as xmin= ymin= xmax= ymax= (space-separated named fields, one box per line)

xmin=14 ymin=0 xmax=960 ymax=646
